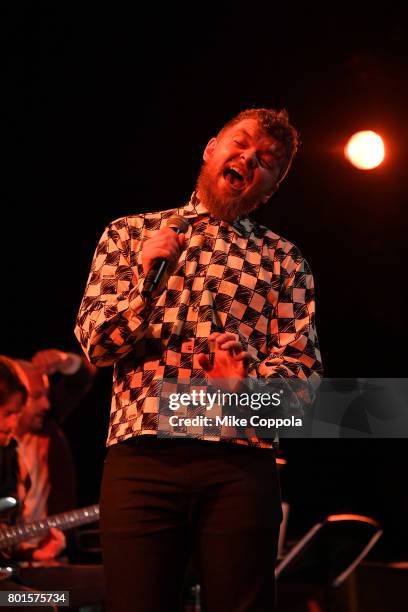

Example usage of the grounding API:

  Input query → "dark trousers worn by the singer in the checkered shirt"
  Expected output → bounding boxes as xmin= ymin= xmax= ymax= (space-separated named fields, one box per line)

xmin=101 ymin=436 xmax=282 ymax=612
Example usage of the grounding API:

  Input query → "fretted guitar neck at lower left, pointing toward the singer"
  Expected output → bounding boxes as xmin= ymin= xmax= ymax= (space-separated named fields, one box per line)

xmin=0 ymin=504 xmax=99 ymax=549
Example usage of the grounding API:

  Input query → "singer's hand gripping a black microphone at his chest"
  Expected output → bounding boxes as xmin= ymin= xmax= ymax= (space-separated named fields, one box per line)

xmin=142 ymin=215 xmax=189 ymax=298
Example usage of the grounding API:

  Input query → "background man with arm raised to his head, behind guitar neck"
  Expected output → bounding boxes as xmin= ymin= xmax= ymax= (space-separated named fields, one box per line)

xmin=16 ymin=349 xmax=96 ymax=557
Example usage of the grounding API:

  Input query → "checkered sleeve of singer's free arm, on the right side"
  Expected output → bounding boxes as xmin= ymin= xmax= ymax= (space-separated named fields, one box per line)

xmin=250 ymin=252 xmax=322 ymax=412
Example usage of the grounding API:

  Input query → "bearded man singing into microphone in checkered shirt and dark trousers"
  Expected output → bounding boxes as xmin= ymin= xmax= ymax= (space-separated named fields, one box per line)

xmin=76 ymin=109 xmax=321 ymax=612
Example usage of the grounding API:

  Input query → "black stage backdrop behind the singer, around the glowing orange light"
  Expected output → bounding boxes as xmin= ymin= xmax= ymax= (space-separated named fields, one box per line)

xmin=0 ymin=2 xmax=408 ymax=557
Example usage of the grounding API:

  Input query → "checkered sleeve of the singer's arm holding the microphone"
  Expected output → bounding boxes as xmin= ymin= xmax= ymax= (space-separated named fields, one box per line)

xmin=75 ymin=216 xmax=157 ymax=366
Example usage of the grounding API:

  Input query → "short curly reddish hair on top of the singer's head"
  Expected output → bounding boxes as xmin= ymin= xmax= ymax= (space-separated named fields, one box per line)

xmin=218 ymin=108 xmax=300 ymax=182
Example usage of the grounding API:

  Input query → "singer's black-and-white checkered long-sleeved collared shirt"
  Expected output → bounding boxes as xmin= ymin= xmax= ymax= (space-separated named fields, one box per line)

xmin=75 ymin=194 xmax=321 ymax=447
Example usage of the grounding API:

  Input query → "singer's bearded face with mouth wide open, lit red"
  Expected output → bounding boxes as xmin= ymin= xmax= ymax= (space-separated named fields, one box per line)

xmin=197 ymin=119 xmax=284 ymax=221
